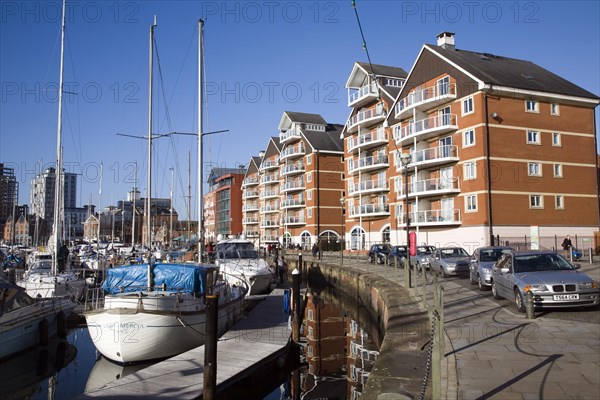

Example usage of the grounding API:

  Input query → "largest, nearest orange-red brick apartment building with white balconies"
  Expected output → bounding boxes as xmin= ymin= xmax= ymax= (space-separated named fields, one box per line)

xmin=344 ymin=32 xmax=599 ymax=251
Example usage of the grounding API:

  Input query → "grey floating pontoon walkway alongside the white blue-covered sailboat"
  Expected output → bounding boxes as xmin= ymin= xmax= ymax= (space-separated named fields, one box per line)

xmin=79 ymin=289 xmax=291 ymax=399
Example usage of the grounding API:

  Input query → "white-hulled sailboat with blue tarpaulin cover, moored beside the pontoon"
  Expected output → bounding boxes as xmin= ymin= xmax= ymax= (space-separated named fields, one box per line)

xmin=84 ymin=20 xmax=248 ymax=364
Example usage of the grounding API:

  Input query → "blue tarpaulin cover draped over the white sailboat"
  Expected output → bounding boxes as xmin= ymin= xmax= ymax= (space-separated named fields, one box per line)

xmin=102 ymin=264 xmax=211 ymax=294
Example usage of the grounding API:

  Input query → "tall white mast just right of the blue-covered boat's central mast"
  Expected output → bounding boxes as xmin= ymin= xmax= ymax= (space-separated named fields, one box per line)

xmin=198 ymin=19 xmax=204 ymax=263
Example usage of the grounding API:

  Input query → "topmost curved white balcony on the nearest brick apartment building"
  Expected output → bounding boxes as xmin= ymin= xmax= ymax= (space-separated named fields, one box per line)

xmin=394 ymin=83 xmax=456 ymax=119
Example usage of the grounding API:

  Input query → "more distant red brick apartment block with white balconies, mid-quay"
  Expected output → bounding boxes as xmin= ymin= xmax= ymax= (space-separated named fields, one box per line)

xmin=242 ymin=111 xmax=344 ymax=249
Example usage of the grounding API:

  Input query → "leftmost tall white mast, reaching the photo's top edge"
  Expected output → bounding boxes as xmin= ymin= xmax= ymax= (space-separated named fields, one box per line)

xmin=52 ymin=0 xmax=67 ymax=274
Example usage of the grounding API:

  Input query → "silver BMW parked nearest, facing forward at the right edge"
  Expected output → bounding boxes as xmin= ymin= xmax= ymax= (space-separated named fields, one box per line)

xmin=492 ymin=251 xmax=600 ymax=312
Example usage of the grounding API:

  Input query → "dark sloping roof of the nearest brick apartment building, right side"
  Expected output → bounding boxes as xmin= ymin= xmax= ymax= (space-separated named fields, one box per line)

xmin=425 ymin=44 xmax=598 ymax=99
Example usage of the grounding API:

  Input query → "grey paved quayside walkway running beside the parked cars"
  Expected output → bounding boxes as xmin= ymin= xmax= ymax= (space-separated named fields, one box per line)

xmin=328 ymin=256 xmax=600 ymax=400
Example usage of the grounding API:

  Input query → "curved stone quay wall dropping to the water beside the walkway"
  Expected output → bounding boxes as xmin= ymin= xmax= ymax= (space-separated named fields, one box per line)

xmin=289 ymin=260 xmax=431 ymax=400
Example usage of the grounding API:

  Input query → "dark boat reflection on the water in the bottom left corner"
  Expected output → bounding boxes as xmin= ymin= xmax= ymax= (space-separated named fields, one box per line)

xmin=0 ymin=338 xmax=77 ymax=399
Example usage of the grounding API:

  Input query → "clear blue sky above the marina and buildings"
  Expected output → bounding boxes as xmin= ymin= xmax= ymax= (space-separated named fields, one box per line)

xmin=0 ymin=0 xmax=600 ymax=218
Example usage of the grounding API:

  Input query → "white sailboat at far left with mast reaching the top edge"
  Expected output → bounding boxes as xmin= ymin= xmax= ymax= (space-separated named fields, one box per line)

xmin=17 ymin=0 xmax=86 ymax=300
